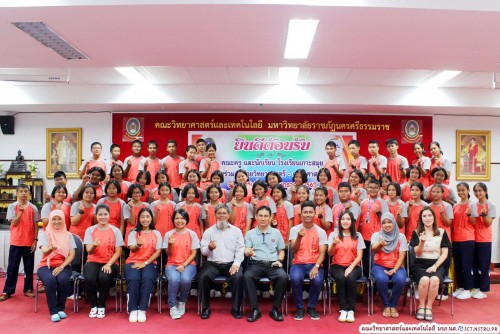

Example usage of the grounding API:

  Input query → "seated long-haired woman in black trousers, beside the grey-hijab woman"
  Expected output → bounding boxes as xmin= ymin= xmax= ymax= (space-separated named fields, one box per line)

xmin=328 ymin=211 xmax=366 ymax=322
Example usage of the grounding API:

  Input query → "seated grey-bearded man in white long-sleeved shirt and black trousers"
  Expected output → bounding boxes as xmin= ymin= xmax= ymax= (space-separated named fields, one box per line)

xmin=198 ymin=204 xmax=245 ymax=319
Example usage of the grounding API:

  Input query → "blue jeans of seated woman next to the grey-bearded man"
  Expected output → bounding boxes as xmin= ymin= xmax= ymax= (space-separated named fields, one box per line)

xmin=165 ymin=264 xmax=196 ymax=307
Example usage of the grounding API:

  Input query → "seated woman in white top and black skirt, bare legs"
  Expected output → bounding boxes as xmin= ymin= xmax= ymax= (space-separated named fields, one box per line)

xmin=410 ymin=207 xmax=450 ymax=321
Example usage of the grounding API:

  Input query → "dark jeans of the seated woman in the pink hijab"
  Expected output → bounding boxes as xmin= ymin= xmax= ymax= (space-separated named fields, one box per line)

xmin=37 ymin=266 xmax=72 ymax=315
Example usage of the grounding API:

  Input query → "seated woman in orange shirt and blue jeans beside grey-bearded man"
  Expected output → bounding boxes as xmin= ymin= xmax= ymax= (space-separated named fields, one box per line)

xmin=163 ymin=209 xmax=200 ymax=319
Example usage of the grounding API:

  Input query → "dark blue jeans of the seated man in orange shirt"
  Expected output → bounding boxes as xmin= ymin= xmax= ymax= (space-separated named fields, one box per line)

xmin=290 ymin=263 xmax=324 ymax=309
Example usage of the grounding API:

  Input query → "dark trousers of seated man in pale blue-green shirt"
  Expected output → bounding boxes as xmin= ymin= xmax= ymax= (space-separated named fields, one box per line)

xmin=243 ymin=261 xmax=288 ymax=310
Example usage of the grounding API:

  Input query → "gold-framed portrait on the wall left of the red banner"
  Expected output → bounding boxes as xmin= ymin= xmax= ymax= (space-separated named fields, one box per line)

xmin=46 ymin=128 xmax=82 ymax=179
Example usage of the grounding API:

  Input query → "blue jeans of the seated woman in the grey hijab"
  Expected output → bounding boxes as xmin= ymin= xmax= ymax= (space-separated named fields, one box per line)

xmin=372 ymin=264 xmax=406 ymax=308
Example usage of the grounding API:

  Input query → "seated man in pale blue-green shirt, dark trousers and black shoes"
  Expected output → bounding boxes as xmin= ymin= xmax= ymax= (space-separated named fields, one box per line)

xmin=243 ymin=206 xmax=288 ymax=322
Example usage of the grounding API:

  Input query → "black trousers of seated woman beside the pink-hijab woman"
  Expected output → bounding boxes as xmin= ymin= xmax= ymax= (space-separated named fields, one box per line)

xmin=83 ymin=262 xmax=118 ymax=308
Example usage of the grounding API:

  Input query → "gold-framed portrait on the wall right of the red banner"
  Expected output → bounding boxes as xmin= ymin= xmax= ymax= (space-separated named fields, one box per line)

xmin=456 ymin=130 xmax=491 ymax=181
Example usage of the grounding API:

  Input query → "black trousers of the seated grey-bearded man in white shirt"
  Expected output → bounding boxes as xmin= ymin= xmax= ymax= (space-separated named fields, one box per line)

xmin=198 ymin=261 xmax=243 ymax=310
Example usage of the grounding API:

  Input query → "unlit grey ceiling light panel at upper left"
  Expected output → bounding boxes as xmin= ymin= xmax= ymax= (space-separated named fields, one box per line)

xmin=12 ymin=22 xmax=89 ymax=59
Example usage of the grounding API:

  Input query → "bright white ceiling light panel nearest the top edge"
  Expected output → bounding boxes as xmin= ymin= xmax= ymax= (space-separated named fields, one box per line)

xmin=285 ymin=19 xmax=319 ymax=59
